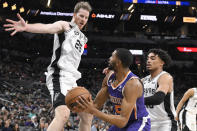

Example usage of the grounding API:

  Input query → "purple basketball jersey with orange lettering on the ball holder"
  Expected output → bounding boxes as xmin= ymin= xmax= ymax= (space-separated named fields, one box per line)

xmin=107 ymin=71 xmax=148 ymax=124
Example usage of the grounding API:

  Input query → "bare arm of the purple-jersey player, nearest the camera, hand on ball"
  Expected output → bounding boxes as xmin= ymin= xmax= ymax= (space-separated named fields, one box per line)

xmin=77 ymin=79 xmax=143 ymax=128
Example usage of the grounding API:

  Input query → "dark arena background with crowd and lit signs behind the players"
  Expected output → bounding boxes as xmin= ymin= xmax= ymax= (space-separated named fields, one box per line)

xmin=0 ymin=0 xmax=197 ymax=131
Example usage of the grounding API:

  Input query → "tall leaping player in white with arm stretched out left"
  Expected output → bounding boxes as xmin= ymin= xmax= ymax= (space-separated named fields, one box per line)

xmin=4 ymin=2 xmax=92 ymax=131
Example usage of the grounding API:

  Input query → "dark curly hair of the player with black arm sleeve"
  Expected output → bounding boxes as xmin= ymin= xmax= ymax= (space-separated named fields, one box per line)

xmin=148 ymin=49 xmax=172 ymax=67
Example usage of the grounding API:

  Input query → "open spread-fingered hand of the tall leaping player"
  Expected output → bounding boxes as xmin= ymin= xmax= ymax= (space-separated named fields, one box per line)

xmin=3 ymin=13 xmax=27 ymax=36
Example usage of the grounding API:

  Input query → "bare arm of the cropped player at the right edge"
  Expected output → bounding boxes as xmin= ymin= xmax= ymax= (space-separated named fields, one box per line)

xmin=175 ymin=89 xmax=194 ymax=121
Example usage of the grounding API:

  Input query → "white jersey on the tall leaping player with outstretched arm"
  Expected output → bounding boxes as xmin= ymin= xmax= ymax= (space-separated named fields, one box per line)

xmin=47 ymin=23 xmax=87 ymax=80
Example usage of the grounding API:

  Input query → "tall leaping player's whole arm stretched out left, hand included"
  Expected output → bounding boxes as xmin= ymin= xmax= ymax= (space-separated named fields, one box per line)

xmin=3 ymin=14 xmax=70 ymax=36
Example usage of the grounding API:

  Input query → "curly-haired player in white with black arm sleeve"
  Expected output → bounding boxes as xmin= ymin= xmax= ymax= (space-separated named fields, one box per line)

xmin=142 ymin=49 xmax=177 ymax=131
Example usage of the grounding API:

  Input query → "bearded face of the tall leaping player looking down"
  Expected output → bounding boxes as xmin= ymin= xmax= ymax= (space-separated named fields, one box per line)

xmin=73 ymin=8 xmax=90 ymax=30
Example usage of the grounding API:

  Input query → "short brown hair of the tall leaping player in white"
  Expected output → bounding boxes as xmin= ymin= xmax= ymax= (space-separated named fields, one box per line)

xmin=74 ymin=1 xmax=92 ymax=13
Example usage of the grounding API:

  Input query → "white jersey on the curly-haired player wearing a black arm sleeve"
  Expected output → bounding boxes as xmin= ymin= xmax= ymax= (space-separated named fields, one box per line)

xmin=143 ymin=71 xmax=175 ymax=123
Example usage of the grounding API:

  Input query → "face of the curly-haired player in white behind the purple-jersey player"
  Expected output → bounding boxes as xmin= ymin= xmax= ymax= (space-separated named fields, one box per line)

xmin=146 ymin=53 xmax=164 ymax=71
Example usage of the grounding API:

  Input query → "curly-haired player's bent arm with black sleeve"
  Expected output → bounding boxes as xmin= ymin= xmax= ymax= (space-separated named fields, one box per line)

xmin=144 ymin=73 xmax=173 ymax=105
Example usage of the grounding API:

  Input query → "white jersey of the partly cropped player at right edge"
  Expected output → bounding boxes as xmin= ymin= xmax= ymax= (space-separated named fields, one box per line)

xmin=185 ymin=88 xmax=197 ymax=114
